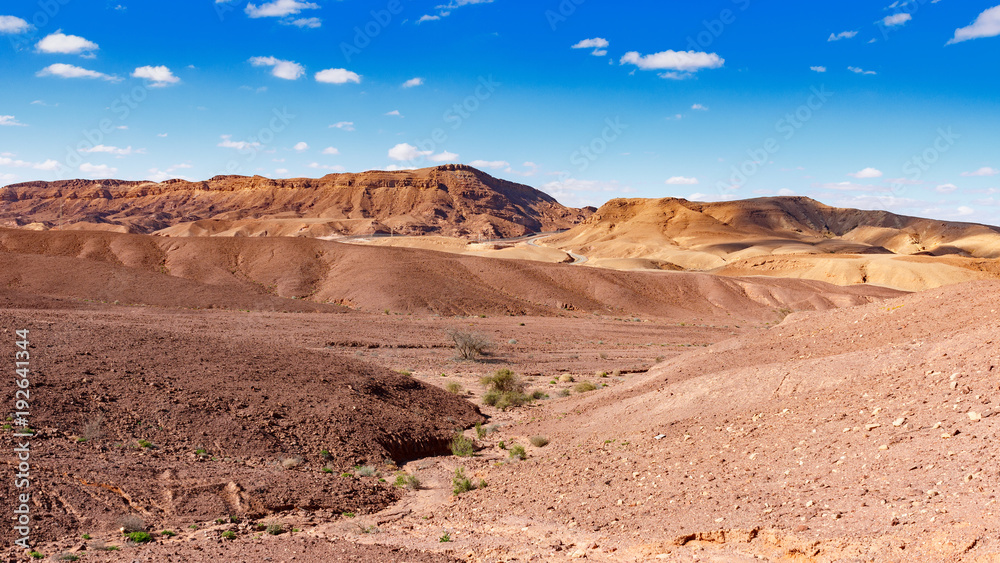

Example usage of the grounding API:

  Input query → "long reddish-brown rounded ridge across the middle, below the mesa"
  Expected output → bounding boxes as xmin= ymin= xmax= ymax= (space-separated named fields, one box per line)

xmin=0 ymin=229 xmax=899 ymax=320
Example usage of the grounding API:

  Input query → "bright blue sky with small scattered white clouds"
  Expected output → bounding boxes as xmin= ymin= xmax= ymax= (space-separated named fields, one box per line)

xmin=0 ymin=0 xmax=1000 ymax=224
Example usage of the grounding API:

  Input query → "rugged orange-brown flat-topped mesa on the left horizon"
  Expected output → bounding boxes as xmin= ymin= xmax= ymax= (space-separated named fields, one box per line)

xmin=0 ymin=164 xmax=592 ymax=238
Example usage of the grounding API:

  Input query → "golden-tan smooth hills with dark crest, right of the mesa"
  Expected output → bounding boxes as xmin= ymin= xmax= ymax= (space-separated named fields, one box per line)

xmin=542 ymin=197 xmax=1000 ymax=290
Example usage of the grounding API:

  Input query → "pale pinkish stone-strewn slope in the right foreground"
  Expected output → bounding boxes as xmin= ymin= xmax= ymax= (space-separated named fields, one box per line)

xmin=440 ymin=282 xmax=1000 ymax=561
